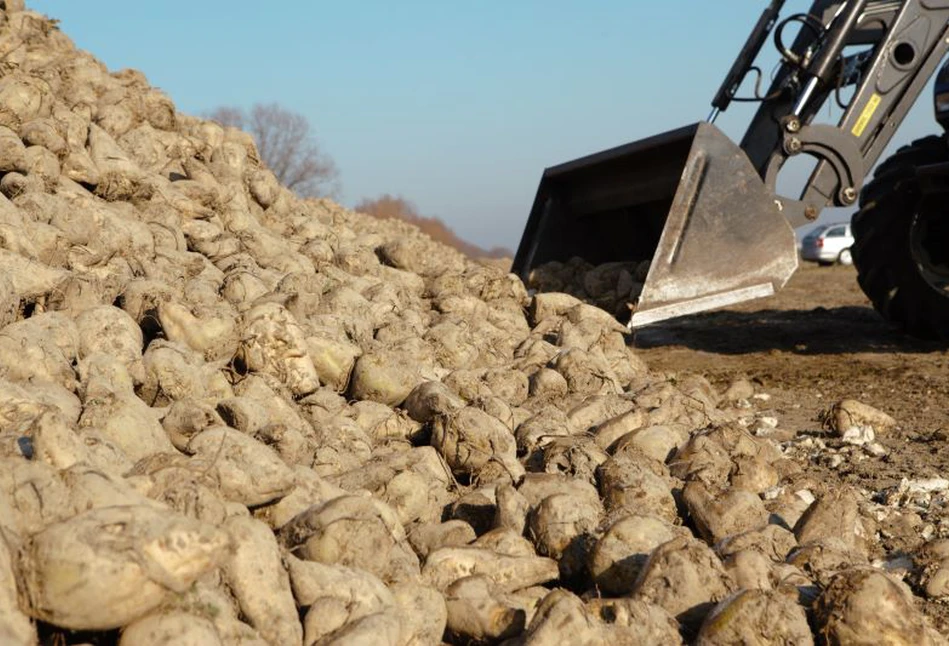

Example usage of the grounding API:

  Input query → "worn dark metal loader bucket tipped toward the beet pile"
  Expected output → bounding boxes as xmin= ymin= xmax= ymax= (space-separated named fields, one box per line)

xmin=512 ymin=123 xmax=797 ymax=327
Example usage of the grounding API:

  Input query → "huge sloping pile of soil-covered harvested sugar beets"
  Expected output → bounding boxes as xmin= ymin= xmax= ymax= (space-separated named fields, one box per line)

xmin=0 ymin=0 xmax=949 ymax=645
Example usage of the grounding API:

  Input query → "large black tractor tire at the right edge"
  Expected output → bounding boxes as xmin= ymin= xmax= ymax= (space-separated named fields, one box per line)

xmin=851 ymin=136 xmax=949 ymax=339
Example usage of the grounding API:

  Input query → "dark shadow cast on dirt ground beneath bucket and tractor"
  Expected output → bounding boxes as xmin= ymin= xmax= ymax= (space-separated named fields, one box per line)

xmin=633 ymin=306 xmax=945 ymax=355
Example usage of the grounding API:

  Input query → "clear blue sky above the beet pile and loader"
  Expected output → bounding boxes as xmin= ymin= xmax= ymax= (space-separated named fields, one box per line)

xmin=27 ymin=0 xmax=937 ymax=248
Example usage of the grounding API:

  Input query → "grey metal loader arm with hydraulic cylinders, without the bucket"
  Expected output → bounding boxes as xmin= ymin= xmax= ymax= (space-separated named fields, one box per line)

xmin=739 ymin=0 xmax=949 ymax=226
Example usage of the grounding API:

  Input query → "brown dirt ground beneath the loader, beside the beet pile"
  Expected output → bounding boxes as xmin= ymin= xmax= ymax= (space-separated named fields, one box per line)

xmin=634 ymin=263 xmax=949 ymax=634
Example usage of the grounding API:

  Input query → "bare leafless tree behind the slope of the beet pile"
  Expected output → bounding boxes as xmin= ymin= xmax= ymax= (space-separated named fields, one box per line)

xmin=209 ymin=103 xmax=339 ymax=197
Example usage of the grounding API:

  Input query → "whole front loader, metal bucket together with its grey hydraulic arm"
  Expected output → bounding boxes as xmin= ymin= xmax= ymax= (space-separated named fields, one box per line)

xmin=513 ymin=0 xmax=949 ymax=327
